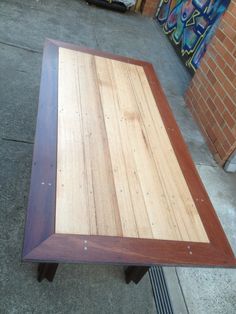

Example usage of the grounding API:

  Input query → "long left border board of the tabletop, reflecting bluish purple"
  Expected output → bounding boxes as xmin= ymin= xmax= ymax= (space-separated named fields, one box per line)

xmin=23 ymin=41 xmax=58 ymax=255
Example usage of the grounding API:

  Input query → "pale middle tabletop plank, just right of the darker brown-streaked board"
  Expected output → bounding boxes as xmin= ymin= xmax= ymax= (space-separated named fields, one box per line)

xmin=95 ymin=57 xmax=152 ymax=238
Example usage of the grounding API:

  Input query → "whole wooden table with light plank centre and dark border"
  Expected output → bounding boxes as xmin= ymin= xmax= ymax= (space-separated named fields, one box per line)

xmin=23 ymin=40 xmax=235 ymax=283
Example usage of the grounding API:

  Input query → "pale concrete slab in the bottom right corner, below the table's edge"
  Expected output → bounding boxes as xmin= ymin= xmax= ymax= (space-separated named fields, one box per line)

xmin=177 ymin=268 xmax=236 ymax=314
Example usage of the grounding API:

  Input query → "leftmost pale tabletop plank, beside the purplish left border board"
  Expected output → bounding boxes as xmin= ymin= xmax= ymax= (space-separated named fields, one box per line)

xmin=56 ymin=49 xmax=90 ymax=234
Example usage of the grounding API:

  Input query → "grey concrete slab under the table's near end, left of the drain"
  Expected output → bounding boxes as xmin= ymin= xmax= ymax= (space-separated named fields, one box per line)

xmin=0 ymin=141 xmax=155 ymax=314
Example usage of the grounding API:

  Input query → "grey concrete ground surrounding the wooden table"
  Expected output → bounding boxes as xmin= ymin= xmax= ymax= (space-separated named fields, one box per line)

xmin=0 ymin=0 xmax=236 ymax=314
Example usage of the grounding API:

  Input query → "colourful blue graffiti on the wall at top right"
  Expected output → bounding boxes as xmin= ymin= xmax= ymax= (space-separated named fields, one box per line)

xmin=157 ymin=0 xmax=230 ymax=71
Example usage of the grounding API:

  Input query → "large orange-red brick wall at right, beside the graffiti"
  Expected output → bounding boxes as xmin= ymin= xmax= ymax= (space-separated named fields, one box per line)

xmin=185 ymin=0 xmax=236 ymax=165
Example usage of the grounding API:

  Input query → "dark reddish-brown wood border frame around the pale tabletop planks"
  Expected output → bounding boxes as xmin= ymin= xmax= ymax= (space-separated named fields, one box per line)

xmin=23 ymin=40 xmax=236 ymax=267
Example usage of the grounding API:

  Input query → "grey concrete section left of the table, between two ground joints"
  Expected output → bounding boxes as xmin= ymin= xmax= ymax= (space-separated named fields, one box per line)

xmin=0 ymin=44 xmax=42 ymax=141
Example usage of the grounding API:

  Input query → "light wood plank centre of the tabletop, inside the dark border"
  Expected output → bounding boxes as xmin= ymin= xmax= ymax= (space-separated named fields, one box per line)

xmin=56 ymin=48 xmax=209 ymax=242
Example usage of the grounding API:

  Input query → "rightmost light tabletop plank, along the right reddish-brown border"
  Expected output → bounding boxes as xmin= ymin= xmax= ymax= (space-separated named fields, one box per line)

xmin=127 ymin=65 xmax=208 ymax=242
